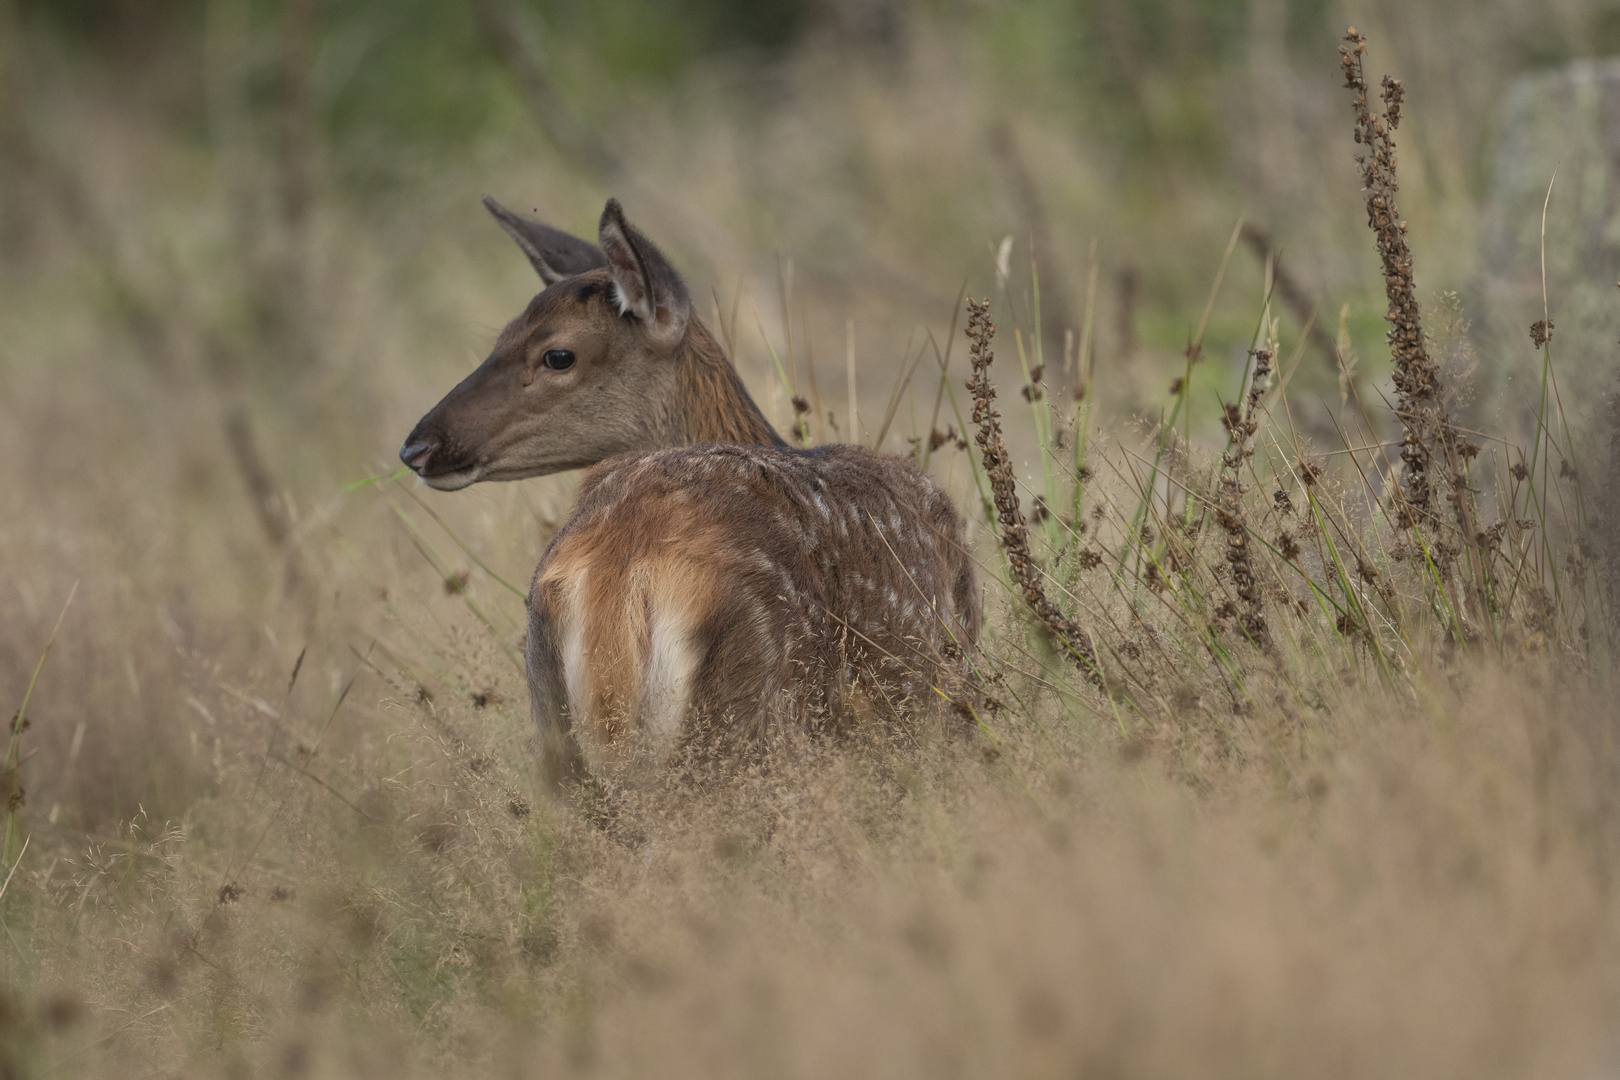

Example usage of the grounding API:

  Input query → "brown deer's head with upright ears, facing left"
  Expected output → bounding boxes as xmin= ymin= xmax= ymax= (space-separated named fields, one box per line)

xmin=400 ymin=198 xmax=703 ymax=491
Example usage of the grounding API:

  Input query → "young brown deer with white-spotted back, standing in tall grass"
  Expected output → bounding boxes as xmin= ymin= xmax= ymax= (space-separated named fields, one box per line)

xmin=400 ymin=196 xmax=980 ymax=790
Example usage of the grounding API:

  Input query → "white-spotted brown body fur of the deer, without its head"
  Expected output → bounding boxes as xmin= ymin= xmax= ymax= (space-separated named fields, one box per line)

xmin=530 ymin=444 xmax=978 ymax=790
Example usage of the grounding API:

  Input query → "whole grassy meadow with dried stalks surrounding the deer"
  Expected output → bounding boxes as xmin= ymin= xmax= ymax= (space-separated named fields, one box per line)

xmin=0 ymin=0 xmax=1620 ymax=1077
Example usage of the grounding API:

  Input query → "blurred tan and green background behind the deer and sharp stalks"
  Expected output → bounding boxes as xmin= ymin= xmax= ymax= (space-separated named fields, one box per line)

xmin=0 ymin=0 xmax=1620 ymax=826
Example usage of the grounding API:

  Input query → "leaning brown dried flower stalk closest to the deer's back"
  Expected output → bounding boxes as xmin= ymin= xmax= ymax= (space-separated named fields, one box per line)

xmin=967 ymin=300 xmax=1102 ymax=685
